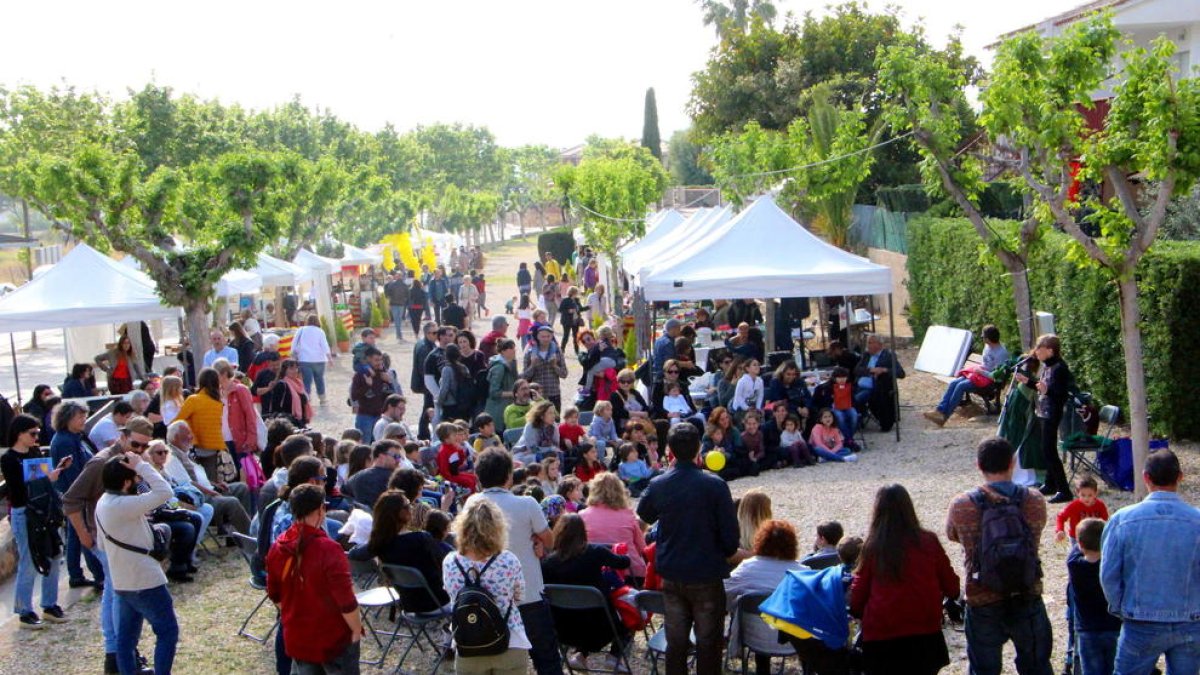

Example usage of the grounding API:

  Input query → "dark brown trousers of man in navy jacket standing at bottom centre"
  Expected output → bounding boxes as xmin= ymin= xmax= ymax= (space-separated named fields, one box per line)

xmin=662 ymin=571 xmax=725 ymax=675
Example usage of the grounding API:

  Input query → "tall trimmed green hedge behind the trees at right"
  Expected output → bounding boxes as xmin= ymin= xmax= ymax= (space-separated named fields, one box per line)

xmin=908 ymin=219 xmax=1200 ymax=438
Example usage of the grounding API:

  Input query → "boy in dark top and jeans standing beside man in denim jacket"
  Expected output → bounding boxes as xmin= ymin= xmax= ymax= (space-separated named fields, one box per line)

xmin=1067 ymin=518 xmax=1121 ymax=674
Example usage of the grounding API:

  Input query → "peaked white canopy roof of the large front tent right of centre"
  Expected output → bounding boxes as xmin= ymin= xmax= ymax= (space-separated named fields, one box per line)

xmin=642 ymin=197 xmax=892 ymax=300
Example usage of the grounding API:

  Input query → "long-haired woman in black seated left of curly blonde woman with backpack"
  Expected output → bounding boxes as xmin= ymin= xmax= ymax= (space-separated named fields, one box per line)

xmin=349 ymin=490 xmax=450 ymax=611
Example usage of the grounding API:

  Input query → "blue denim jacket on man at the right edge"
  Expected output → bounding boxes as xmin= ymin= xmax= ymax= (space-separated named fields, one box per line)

xmin=1100 ymin=491 xmax=1200 ymax=623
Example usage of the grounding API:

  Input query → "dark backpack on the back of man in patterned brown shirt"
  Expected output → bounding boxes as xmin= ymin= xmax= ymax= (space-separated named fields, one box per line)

xmin=971 ymin=486 xmax=1042 ymax=596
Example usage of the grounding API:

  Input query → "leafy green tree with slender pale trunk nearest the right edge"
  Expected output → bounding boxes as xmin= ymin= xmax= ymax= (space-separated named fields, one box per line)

xmin=982 ymin=14 xmax=1200 ymax=495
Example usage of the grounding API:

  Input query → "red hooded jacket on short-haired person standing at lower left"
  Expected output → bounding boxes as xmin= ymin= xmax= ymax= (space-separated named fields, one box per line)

xmin=266 ymin=522 xmax=359 ymax=663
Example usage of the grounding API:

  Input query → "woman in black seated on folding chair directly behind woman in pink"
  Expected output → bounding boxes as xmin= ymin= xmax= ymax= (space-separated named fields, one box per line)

xmin=541 ymin=509 xmax=630 ymax=670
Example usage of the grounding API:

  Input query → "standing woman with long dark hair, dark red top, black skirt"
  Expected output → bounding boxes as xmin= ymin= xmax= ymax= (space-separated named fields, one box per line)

xmin=850 ymin=484 xmax=959 ymax=675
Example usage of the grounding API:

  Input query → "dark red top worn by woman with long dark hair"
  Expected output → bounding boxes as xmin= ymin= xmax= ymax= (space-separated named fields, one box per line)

xmin=850 ymin=532 xmax=959 ymax=640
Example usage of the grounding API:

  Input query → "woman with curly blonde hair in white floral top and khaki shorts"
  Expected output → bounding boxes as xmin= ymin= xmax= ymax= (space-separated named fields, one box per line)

xmin=442 ymin=495 xmax=532 ymax=674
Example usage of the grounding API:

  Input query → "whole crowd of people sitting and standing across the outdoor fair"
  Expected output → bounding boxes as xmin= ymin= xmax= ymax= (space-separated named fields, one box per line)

xmin=0 ymin=249 xmax=1200 ymax=675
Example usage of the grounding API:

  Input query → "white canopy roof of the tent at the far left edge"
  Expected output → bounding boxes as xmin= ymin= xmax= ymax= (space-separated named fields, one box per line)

xmin=0 ymin=244 xmax=179 ymax=333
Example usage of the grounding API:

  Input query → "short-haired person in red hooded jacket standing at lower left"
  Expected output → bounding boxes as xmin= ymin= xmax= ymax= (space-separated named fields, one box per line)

xmin=266 ymin=484 xmax=362 ymax=675
